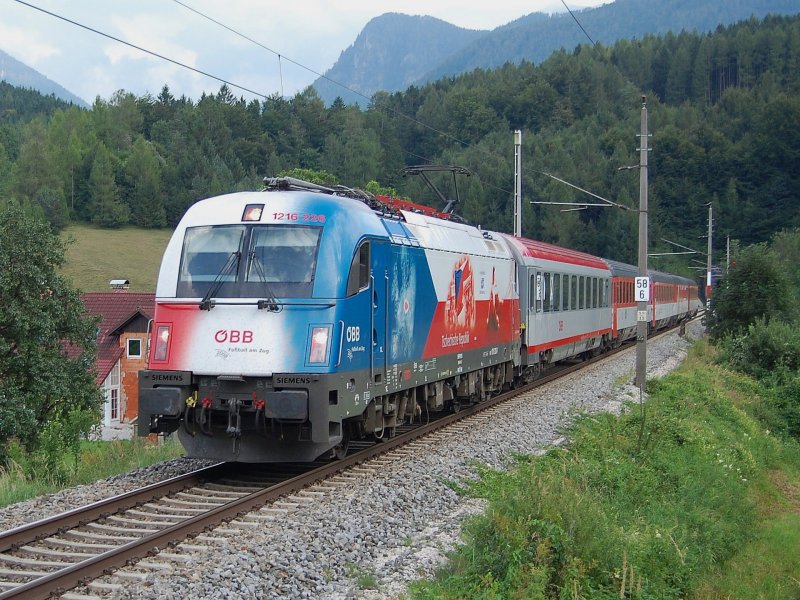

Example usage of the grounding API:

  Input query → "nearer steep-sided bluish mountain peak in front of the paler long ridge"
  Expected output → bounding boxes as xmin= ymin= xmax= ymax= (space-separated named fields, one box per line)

xmin=314 ymin=13 xmax=488 ymax=105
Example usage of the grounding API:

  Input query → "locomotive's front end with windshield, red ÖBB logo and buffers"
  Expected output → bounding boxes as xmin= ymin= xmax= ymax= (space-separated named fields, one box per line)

xmin=139 ymin=191 xmax=386 ymax=462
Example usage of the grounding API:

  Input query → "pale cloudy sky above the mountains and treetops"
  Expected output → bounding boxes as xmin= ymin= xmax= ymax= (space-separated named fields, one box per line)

xmin=0 ymin=0 xmax=610 ymax=103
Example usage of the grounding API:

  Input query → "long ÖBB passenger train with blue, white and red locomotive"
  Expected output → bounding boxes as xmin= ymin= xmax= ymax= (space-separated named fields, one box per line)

xmin=138 ymin=178 xmax=701 ymax=462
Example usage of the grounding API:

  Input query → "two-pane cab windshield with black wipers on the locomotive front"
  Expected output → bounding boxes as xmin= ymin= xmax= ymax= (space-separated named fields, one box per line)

xmin=178 ymin=225 xmax=322 ymax=298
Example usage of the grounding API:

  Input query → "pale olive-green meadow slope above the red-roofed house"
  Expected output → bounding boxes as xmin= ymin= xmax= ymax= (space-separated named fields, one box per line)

xmin=62 ymin=225 xmax=172 ymax=292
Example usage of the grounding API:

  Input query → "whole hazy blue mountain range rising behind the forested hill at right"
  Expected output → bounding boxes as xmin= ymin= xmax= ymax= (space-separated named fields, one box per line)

xmin=314 ymin=0 xmax=800 ymax=105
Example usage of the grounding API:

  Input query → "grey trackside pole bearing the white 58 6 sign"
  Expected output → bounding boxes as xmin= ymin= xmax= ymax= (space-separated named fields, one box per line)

xmin=635 ymin=96 xmax=652 ymax=393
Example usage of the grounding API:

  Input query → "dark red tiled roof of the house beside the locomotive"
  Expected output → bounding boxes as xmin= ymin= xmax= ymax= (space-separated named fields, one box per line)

xmin=81 ymin=292 xmax=155 ymax=384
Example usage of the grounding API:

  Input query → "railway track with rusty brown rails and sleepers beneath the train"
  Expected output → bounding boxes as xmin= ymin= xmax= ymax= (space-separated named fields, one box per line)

xmin=0 ymin=324 xmax=688 ymax=600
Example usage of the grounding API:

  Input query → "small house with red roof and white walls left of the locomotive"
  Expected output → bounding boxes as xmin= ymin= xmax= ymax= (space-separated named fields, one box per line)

xmin=81 ymin=292 xmax=155 ymax=440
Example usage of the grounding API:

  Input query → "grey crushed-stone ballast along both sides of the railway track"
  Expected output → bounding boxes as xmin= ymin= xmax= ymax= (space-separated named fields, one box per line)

xmin=0 ymin=320 xmax=703 ymax=600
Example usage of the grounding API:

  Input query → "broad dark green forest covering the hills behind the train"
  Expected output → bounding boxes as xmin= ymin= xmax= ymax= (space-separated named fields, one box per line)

xmin=0 ymin=17 xmax=800 ymax=272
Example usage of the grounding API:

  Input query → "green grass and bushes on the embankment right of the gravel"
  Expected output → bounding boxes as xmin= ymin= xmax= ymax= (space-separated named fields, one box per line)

xmin=409 ymin=231 xmax=800 ymax=600
